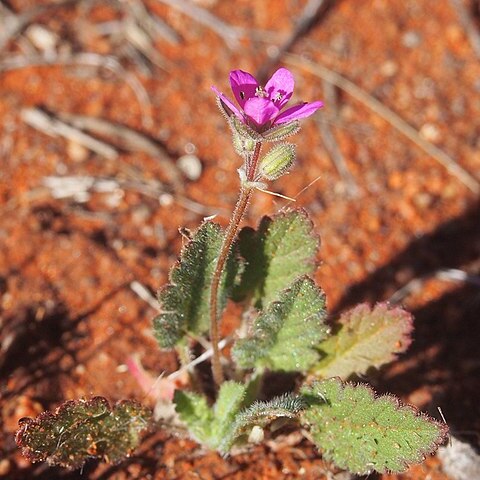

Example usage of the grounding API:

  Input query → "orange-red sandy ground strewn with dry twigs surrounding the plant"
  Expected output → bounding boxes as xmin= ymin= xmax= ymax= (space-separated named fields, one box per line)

xmin=0 ymin=0 xmax=480 ymax=479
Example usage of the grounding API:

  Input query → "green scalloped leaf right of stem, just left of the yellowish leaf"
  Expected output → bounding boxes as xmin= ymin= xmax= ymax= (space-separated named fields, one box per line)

xmin=232 ymin=277 xmax=328 ymax=372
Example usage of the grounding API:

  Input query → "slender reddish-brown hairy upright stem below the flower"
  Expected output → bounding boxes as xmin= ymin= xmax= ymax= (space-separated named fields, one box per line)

xmin=210 ymin=143 xmax=261 ymax=386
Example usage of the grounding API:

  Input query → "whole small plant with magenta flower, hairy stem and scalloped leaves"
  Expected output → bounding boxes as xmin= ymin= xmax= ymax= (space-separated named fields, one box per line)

xmin=17 ymin=68 xmax=447 ymax=474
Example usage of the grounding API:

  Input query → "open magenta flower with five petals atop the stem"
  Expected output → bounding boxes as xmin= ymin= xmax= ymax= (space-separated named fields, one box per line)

xmin=212 ymin=68 xmax=323 ymax=132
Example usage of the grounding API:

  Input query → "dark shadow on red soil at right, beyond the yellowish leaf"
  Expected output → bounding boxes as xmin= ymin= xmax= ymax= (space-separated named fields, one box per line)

xmin=335 ymin=199 xmax=480 ymax=434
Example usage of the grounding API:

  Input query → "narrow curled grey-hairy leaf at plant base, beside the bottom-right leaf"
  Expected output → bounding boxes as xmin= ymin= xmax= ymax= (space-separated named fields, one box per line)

xmin=219 ymin=394 xmax=305 ymax=454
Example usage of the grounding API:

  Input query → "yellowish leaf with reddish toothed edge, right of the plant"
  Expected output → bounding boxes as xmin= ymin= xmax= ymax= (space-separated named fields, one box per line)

xmin=312 ymin=303 xmax=413 ymax=379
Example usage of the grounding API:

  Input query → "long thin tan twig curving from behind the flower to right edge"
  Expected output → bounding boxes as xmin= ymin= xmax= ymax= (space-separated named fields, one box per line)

xmin=285 ymin=54 xmax=480 ymax=195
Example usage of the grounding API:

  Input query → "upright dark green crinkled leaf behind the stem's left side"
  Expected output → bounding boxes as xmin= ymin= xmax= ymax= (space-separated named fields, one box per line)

xmin=153 ymin=222 xmax=238 ymax=348
